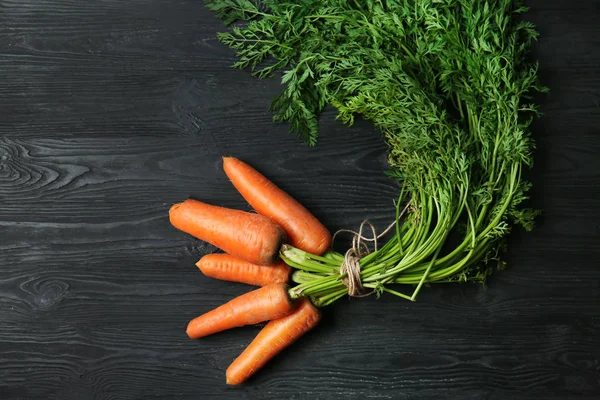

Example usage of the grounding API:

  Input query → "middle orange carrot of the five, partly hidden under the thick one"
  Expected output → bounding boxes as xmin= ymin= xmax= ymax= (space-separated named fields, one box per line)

xmin=196 ymin=254 xmax=291 ymax=286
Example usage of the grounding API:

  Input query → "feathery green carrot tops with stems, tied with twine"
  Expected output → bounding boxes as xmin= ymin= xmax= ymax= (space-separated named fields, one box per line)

xmin=205 ymin=0 xmax=545 ymax=305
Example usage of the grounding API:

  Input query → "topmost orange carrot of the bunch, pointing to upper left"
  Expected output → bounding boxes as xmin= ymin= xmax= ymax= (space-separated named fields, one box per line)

xmin=223 ymin=157 xmax=331 ymax=255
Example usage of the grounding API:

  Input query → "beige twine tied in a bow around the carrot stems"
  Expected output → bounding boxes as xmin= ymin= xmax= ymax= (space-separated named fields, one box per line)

xmin=332 ymin=203 xmax=410 ymax=297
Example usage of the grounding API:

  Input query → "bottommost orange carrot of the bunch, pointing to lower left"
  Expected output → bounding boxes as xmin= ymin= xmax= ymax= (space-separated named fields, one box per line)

xmin=225 ymin=297 xmax=321 ymax=385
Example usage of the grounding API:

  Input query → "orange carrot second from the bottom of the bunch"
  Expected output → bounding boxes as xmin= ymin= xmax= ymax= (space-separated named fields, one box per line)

xmin=186 ymin=283 xmax=295 ymax=339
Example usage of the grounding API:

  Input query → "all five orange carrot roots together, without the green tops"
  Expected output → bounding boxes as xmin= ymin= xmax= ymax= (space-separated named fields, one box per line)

xmin=169 ymin=157 xmax=331 ymax=385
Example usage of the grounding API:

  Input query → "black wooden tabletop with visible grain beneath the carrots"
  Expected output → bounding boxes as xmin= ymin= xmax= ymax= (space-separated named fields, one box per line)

xmin=0 ymin=0 xmax=600 ymax=400
